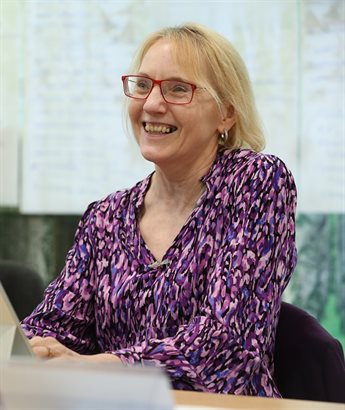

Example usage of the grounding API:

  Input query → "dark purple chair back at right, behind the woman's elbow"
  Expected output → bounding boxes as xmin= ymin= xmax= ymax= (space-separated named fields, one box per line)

xmin=274 ymin=302 xmax=345 ymax=403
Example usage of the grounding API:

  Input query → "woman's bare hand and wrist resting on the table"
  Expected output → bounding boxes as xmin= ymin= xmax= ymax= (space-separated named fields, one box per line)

xmin=30 ymin=336 xmax=121 ymax=363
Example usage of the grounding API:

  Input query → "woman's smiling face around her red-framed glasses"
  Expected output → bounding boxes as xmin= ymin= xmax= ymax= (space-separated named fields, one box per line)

xmin=128 ymin=39 xmax=229 ymax=176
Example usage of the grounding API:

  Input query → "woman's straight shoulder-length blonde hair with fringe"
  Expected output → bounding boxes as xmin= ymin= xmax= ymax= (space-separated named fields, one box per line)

xmin=127 ymin=23 xmax=265 ymax=151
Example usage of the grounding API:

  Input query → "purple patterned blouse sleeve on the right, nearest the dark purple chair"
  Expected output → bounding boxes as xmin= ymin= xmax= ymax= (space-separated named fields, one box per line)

xmin=113 ymin=156 xmax=296 ymax=397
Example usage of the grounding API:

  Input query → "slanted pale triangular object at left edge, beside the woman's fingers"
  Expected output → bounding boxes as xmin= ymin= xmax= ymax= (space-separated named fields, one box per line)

xmin=0 ymin=282 xmax=35 ymax=362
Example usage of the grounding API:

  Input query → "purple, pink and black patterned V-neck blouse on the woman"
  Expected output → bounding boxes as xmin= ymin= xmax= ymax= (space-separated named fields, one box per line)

xmin=22 ymin=149 xmax=296 ymax=397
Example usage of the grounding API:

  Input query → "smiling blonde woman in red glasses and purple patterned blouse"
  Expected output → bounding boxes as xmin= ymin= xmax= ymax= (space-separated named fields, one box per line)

xmin=23 ymin=25 xmax=296 ymax=397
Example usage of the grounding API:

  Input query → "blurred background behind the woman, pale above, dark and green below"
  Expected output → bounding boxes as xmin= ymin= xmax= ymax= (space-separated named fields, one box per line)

xmin=0 ymin=0 xmax=345 ymax=347
